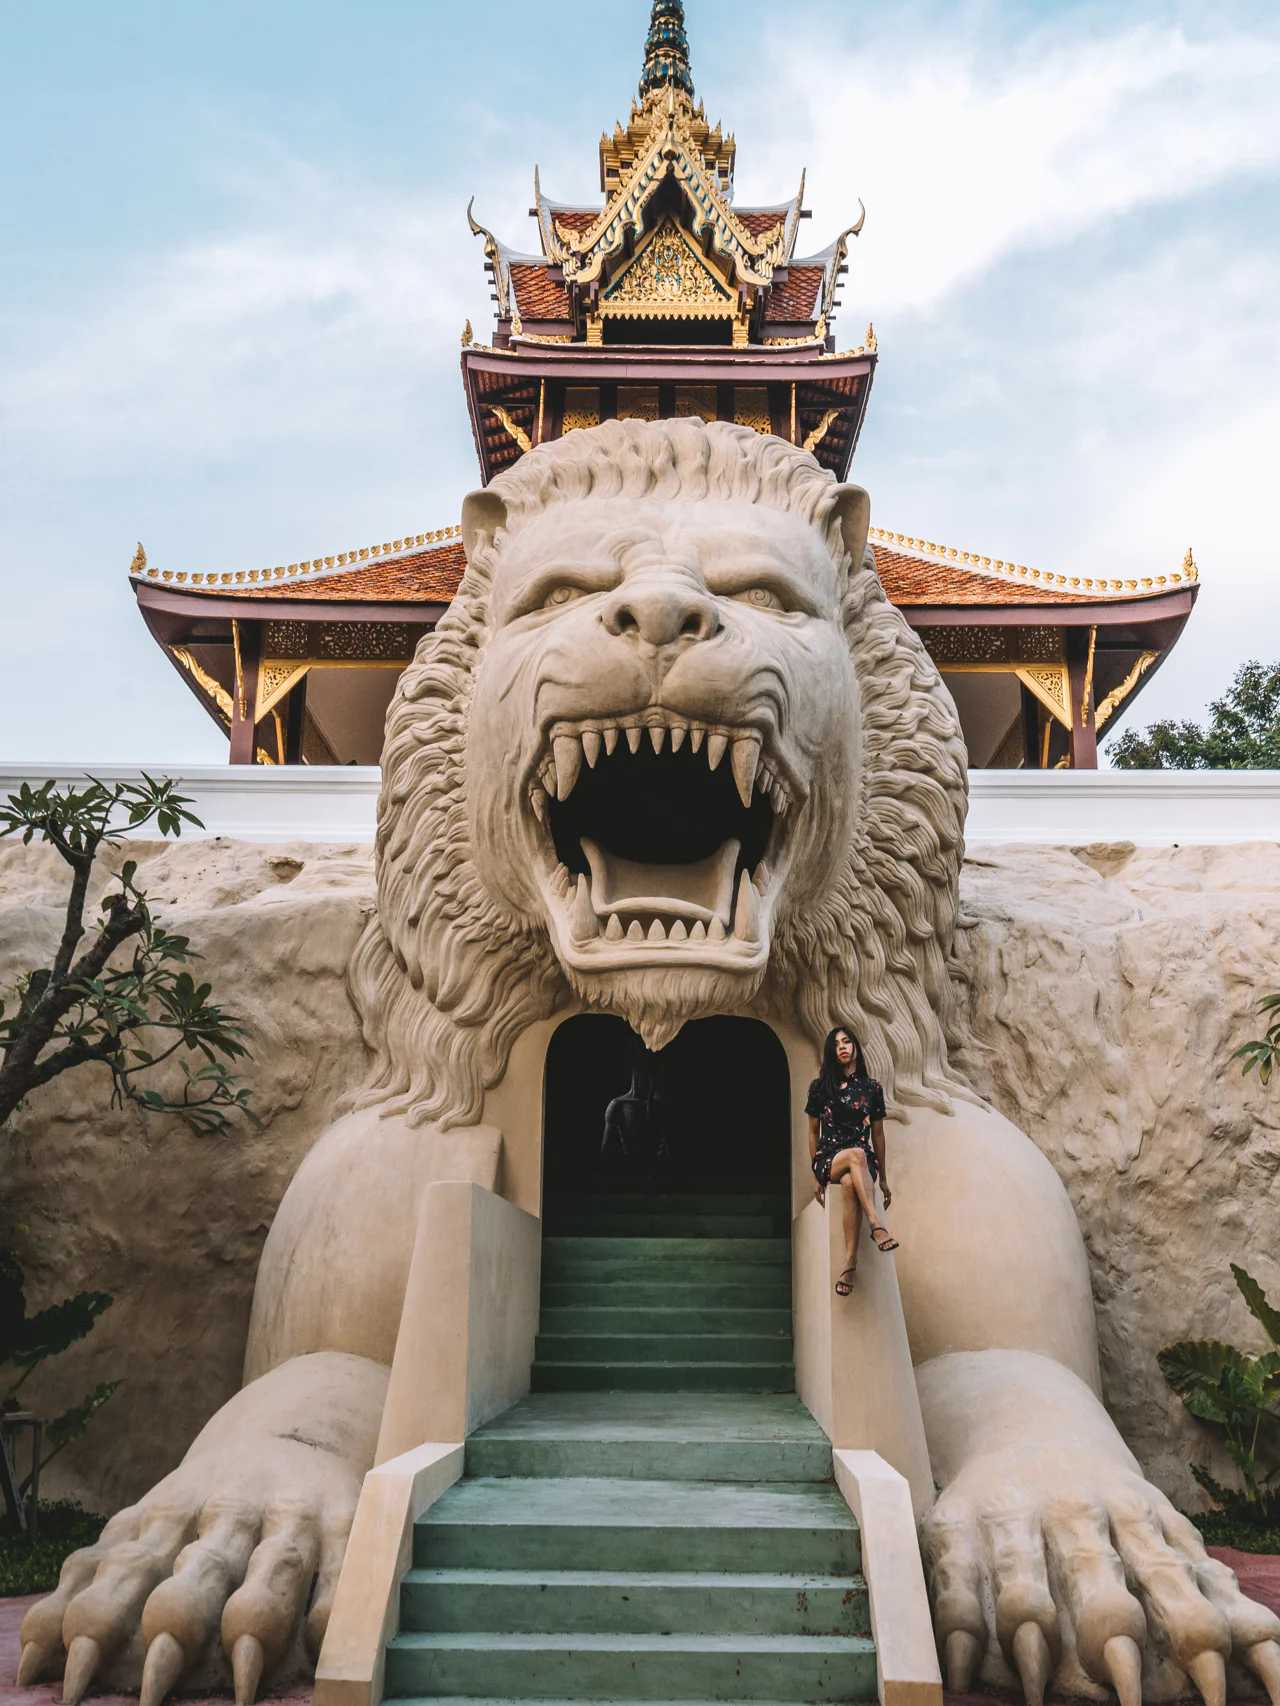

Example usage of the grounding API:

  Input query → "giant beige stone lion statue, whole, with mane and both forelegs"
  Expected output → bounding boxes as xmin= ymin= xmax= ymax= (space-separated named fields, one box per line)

xmin=19 ymin=420 xmax=1280 ymax=1706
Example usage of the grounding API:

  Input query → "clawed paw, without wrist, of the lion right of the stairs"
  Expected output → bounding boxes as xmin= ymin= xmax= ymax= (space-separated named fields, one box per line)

xmin=923 ymin=1450 xmax=1280 ymax=1706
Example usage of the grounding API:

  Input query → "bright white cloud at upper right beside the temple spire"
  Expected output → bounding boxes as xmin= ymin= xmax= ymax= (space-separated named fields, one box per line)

xmin=739 ymin=15 xmax=1280 ymax=312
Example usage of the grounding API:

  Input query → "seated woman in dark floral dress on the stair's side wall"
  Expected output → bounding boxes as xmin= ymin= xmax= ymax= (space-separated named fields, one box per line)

xmin=804 ymin=1025 xmax=898 ymax=1297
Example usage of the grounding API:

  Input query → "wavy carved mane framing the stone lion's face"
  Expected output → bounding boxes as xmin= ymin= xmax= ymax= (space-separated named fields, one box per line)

xmin=350 ymin=418 xmax=968 ymax=1126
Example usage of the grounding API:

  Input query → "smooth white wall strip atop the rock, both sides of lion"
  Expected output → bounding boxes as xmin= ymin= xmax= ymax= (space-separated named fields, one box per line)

xmin=0 ymin=764 xmax=1280 ymax=846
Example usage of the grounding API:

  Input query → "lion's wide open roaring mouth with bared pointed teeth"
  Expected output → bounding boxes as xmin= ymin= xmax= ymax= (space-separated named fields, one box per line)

xmin=531 ymin=711 xmax=794 ymax=969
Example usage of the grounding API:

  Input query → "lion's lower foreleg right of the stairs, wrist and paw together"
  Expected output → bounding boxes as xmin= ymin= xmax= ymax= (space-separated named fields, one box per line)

xmin=916 ymin=1351 xmax=1280 ymax=1706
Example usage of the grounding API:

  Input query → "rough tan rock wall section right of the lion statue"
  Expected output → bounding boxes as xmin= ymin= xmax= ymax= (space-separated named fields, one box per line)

xmin=957 ymin=843 xmax=1280 ymax=1508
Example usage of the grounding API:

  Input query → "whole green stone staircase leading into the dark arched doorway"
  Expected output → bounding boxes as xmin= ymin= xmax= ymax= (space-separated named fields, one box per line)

xmin=386 ymin=1192 xmax=876 ymax=1703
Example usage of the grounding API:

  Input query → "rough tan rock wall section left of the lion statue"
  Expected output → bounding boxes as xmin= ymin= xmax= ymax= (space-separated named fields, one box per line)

xmin=0 ymin=841 xmax=374 ymax=1510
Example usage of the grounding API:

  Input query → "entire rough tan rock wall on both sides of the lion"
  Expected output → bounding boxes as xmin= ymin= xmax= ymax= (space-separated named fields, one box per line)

xmin=0 ymin=841 xmax=1280 ymax=1510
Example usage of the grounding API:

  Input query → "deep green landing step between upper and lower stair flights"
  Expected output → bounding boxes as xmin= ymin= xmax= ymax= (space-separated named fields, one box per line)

xmin=466 ymin=1392 xmax=831 ymax=1483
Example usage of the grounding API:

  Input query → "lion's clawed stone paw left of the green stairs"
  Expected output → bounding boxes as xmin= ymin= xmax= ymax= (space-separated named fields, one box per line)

xmin=17 ymin=1436 xmax=360 ymax=1706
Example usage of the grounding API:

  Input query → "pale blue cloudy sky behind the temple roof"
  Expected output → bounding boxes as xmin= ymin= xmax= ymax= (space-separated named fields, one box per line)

xmin=0 ymin=0 xmax=1280 ymax=766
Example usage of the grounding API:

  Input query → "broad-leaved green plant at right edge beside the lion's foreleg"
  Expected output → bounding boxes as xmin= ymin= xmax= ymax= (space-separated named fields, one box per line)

xmin=1159 ymin=1262 xmax=1280 ymax=1549
